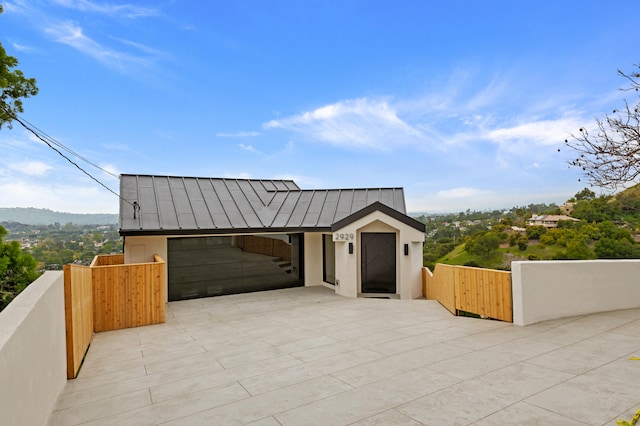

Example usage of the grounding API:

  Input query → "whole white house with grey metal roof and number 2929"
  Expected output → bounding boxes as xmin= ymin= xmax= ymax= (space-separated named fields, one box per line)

xmin=119 ymin=175 xmax=425 ymax=300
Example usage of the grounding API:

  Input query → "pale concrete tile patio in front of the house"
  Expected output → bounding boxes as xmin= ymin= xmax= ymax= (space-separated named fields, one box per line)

xmin=49 ymin=287 xmax=640 ymax=426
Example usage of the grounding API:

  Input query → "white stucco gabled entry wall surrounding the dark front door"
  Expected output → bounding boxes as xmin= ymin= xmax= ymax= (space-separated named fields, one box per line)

xmin=334 ymin=211 xmax=424 ymax=299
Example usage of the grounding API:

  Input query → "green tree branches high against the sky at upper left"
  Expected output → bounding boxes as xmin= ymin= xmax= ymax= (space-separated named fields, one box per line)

xmin=0 ymin=5 xmax=38 ymax=129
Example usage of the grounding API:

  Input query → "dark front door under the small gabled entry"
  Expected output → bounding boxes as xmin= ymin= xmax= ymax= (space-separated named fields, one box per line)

xmin=361 ymin=232 xmax=396 ymax=294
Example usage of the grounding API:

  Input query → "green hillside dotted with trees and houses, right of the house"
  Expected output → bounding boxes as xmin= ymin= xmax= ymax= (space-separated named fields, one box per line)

xmin=417 ymin=185 xmax=640 ymax=269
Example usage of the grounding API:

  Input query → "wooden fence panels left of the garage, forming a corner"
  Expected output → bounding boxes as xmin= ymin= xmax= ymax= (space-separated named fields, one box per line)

xmin=64 ymin=255 xmax=166 ymax=379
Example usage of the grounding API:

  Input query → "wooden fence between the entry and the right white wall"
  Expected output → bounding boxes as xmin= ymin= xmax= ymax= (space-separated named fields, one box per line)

xmin=422 ymin=263 xmax=513 ymax=322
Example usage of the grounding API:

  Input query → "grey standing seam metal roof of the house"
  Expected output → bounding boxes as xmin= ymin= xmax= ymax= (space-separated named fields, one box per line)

xmin=120 ymin=174 xmax=420 ymax=235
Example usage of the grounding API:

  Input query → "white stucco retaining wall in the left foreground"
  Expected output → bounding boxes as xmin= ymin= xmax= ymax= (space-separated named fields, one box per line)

xmin=0 ymin=271 xmax=67 ymax=425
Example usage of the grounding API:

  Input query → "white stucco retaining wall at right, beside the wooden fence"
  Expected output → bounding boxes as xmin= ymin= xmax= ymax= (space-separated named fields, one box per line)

xmin=511 ymin=259 xmax=640 ymax=325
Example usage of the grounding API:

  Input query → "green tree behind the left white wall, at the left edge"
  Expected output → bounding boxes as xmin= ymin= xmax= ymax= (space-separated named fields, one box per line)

xmin=0 ymin=226 xmax=38 ymax=311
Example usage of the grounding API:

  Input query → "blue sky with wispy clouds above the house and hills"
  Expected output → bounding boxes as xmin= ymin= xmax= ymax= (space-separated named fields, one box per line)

xmin=0 ymin=0 xmax=640 ymax=213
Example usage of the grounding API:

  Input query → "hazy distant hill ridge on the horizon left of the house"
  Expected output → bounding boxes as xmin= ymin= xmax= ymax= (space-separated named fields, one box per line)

xmin=0 ymin=207 xmax=118 ymax=225
